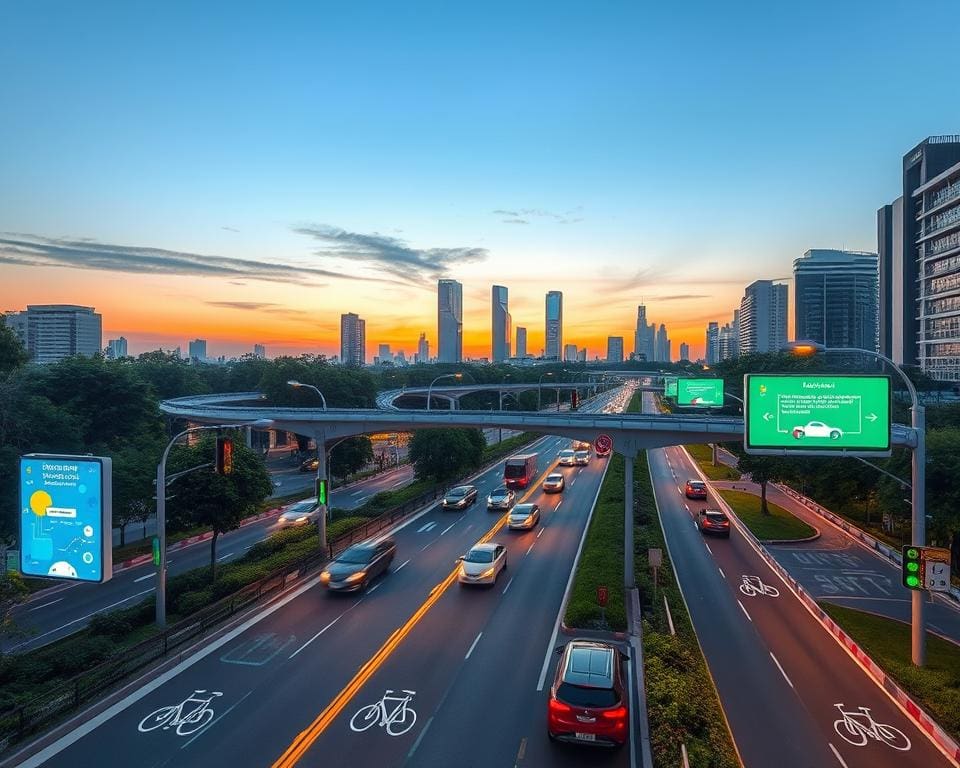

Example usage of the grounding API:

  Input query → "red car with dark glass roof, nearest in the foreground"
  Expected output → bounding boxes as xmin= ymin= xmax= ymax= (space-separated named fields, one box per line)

xmin=547 ymin=639 xmax=630 ymax=747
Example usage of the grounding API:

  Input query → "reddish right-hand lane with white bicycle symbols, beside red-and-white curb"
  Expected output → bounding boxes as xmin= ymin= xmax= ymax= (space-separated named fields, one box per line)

xmin=672 ymin=453 xmax=951 ymax=768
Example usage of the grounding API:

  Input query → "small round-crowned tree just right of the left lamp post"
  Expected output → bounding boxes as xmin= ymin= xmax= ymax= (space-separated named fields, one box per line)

xmin=167 ymin=435 xmax=273 ymax=578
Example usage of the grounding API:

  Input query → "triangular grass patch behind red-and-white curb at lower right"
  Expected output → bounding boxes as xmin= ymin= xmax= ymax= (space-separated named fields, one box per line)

xmin=819 ymin=601 xmax=960 ymax=740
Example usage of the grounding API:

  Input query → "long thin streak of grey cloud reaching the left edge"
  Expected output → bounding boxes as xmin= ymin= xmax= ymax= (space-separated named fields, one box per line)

xmin=0 ymin=232 xmax=369 ymax=285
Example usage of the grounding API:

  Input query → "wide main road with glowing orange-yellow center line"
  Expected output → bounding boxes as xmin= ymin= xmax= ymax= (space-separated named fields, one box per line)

xmin=15 ymin=392 xmax=630 ymax=768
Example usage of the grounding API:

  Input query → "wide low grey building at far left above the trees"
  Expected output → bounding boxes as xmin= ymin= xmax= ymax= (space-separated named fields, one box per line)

xmin=6 ymin=304 xmax=103 ymax=363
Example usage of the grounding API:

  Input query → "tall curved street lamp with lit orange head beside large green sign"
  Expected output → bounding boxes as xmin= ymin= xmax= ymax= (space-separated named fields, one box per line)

xmin=786 ymin=341 xmax=927 ymax=667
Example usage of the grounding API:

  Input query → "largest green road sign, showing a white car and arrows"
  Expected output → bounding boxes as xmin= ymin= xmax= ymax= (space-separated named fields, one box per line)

xmin=743 ymin=373 xmax=890 ymax=456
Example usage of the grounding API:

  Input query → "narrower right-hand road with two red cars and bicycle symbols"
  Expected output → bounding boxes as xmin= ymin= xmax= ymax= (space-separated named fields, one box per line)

xmin=648 ymin=392 xmax=950 ymax=768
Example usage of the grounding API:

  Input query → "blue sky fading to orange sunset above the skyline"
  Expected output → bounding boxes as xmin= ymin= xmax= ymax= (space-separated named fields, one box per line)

xmin=0 ymin=0 xmax=960 ymax=359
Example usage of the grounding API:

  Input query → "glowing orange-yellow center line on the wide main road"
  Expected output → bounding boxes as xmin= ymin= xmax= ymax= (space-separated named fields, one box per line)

xmin=273 ymin=461 xmax=557 ymax=768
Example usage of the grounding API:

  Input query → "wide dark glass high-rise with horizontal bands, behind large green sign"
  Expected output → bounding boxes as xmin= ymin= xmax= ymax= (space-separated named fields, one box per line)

xmin=793 ymin=249 xmax=879 ymax=351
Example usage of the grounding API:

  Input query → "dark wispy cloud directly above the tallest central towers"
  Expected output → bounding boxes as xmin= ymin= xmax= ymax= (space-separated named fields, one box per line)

xmin=293 ymin=225 xmax=490 ymax=284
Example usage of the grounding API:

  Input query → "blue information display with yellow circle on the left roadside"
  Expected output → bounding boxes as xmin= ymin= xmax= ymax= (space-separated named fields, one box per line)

xmin=20 ymin=454 xmax=113 ymax=582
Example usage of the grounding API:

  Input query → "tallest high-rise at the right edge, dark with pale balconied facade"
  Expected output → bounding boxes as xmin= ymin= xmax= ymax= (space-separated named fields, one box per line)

xmin=877 ymin=135 xmax=960 ymax=381
